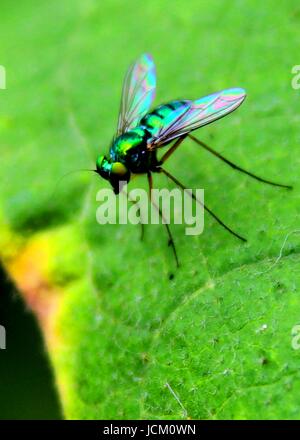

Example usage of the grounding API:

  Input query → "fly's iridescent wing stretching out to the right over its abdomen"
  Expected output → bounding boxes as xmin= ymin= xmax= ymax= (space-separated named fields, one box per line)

xmin=149 ymin=88 xmax=246 ymax=148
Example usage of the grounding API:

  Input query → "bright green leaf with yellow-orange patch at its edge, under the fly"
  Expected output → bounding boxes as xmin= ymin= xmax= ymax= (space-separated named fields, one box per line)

xmin=0 ymin=0 xmax=300 ymax=419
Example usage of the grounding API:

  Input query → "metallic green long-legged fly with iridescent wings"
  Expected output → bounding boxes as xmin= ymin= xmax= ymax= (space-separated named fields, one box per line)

xmin=95 ymin=54 xmax=291 ymax=266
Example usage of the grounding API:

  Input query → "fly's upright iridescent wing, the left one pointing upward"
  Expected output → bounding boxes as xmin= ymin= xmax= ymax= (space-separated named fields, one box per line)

xmin=117 ymin=54 xmax=156 ymax=136
